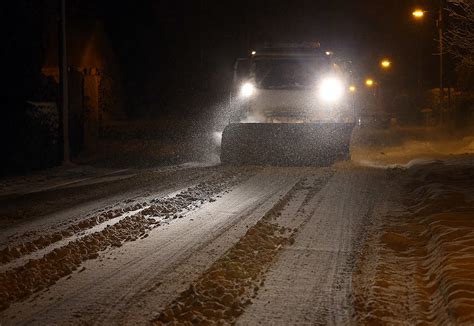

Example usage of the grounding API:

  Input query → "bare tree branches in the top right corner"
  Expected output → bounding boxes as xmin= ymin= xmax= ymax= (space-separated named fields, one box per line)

xmin=445 ymin=0 xmax=474 ymax=67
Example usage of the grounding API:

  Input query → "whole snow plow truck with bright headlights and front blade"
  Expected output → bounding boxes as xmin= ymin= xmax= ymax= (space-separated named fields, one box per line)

xmin=221 ymin=44 xmax=355 ymax=166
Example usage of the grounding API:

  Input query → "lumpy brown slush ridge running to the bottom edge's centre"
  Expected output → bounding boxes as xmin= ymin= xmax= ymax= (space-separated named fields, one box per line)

xmin=155 ymin=174 xmax=329 ymax=325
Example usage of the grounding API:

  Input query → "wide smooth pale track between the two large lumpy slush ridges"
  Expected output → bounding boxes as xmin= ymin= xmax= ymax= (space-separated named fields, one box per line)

xmin=0 ymin=169 xmax=301 ymax=325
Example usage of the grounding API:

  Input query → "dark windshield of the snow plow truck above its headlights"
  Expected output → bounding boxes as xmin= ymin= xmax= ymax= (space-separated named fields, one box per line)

xmin=255 ymin=59 xmax=327 ymax=89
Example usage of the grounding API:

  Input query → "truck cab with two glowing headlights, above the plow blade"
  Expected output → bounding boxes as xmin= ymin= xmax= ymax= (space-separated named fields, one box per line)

xmin=234 ymin=45 xmax=354 ymax=123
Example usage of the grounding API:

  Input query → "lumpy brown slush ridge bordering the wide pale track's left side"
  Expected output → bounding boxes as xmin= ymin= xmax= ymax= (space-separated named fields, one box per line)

xmin=0 ymin=169 xmax=250 ymax=311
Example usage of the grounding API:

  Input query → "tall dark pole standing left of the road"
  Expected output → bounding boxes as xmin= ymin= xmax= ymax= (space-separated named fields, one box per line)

xmin=59 ymin=0 xmax=70 ymax=165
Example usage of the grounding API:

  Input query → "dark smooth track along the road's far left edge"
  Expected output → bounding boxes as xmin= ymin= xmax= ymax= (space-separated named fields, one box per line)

xmin=0 ymin=167 xmax=222 ymax=242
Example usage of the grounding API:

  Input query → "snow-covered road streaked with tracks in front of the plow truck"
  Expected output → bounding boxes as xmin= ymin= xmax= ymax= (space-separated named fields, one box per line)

xmin=0 ymin=155 xmax=472 ymax=325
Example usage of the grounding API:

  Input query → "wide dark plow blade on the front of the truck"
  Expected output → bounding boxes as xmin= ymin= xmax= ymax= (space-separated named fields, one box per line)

xmin=221 ymin=123 xmax=354 ymax=166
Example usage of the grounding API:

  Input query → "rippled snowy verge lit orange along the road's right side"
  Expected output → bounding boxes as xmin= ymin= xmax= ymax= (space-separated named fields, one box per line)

xmin=353 ymin=156 xmax=474 ymax=325
